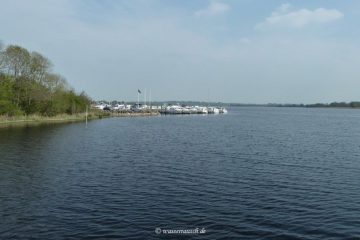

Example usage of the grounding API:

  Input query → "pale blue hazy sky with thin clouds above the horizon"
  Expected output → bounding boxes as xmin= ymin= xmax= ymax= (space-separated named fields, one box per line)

xmin=0 ymin=0 xmax=360 ymax=103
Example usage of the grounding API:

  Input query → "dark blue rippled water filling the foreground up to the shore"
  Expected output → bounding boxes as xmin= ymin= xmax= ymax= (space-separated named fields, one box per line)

xmin=0 ymin=108 xmax=360 ymax=239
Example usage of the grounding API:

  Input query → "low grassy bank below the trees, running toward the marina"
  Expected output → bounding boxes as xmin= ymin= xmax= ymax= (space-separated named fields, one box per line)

xmin=0 ymin=111 xmax=159 ymax=127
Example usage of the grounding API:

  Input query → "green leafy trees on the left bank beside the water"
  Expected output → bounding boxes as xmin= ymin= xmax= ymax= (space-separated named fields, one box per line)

xmin=0 ymin=43 xmax=90 ymax=116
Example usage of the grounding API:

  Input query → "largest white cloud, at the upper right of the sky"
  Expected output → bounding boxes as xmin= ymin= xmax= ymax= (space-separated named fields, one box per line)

xmin=255 ymin=4 xmax=344 ymax=30
